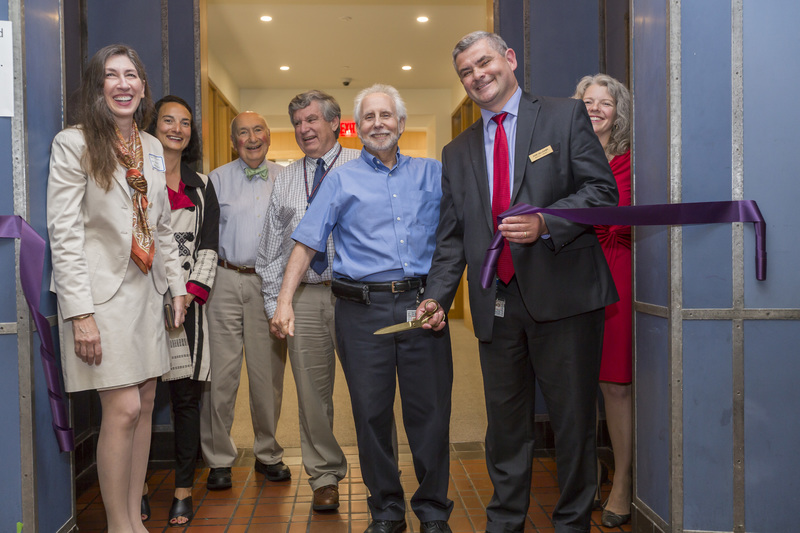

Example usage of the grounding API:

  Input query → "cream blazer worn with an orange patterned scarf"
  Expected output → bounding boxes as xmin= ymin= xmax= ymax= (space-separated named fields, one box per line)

xmin=47 ymin=127 xmax=186 ymax=319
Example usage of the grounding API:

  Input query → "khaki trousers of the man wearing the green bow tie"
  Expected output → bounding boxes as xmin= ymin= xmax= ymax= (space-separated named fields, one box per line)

xmin=200 ymin=267 xmax=286 ymax=468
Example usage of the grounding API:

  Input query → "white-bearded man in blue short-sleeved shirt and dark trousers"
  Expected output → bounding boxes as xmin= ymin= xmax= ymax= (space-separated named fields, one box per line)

xmin=272 ymin=85 xmax=453 ymax=533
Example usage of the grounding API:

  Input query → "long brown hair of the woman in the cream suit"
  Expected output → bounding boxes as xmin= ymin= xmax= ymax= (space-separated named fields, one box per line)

xmin=78 ymin=44 xmax=153 ymax=191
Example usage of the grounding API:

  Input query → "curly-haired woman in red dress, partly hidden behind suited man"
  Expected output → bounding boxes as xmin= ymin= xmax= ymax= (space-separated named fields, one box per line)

xmin=573 ymin=74 xmax=633 ymax=527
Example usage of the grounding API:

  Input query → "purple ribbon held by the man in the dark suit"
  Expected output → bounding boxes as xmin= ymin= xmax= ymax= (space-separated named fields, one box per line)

xmin=481 ymin=200 xmax=767 ymax=289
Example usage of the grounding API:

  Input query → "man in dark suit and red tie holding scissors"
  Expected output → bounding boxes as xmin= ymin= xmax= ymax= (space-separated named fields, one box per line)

xmin=417 ymin=32 xmax=618 ymax=533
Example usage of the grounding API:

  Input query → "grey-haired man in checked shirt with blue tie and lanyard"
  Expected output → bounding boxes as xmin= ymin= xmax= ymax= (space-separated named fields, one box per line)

xmin=256 ymin=91 xmax=360 ymax=511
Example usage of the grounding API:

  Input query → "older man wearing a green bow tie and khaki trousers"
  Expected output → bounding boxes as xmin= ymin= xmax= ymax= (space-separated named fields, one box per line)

xmin=200 ymin=111 xmax=291 ymax=490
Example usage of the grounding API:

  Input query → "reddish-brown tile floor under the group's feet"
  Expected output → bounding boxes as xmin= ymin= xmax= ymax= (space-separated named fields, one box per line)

xmin=77 ymin=443 xmax=631 ymax=533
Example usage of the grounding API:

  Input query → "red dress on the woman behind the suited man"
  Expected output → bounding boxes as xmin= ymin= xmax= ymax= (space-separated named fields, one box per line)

xmin=594 ymin=150 xmax=633 ymax=383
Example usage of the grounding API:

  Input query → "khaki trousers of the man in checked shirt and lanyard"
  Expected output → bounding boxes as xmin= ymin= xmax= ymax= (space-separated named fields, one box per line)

xmin=288 ymin=284 xmax=347 ymax=490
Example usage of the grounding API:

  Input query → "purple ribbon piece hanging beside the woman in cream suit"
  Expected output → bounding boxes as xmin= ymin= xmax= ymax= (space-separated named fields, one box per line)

xmin=0 ymin=215 xmax=75 ymax=452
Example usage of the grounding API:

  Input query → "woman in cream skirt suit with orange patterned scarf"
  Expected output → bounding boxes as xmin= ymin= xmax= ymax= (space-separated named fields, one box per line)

xmin=47 ymin=45 xmax=186 ymax=533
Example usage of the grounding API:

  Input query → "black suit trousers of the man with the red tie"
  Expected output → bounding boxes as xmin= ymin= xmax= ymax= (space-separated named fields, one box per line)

xmin=479 ymin=278 xmax=604 ymax=533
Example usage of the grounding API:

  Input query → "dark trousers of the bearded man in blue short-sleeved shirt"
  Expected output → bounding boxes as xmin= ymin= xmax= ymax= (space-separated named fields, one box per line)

xmin=335 ymin=291 xmax=453 ymax=522
